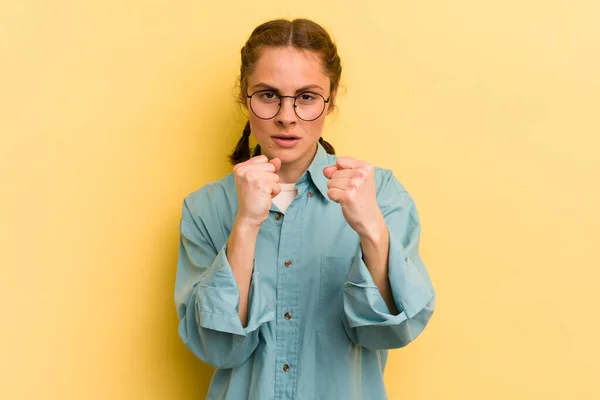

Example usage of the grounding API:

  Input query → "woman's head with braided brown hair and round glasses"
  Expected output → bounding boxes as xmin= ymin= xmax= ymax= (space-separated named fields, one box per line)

xmin=230 ymin=19 xmax=342 ymax=166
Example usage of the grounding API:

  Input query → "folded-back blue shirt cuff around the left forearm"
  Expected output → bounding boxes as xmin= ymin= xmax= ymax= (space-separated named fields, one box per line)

xmin=195 ymin=244 xmax=275 ymax=336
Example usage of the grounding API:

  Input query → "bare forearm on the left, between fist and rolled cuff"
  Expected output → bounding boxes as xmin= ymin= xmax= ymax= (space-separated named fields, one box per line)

xmin=227 ymin=220 xmax=259 ymax=327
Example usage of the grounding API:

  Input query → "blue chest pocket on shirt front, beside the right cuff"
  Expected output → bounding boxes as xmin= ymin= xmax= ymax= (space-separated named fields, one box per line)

xmin=317 ymin=257 xmax=354 ymax=339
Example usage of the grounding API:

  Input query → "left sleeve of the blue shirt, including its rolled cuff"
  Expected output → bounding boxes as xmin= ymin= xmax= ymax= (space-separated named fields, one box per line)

xmin=175 ymin=202 xmax=275 ymax=368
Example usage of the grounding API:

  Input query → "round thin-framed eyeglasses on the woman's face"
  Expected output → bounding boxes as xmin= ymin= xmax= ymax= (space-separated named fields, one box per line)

xmin=246 ymin=90 xmax=329 ymax=121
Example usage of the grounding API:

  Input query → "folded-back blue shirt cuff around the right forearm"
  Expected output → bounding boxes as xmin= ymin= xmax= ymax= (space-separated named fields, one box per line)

xmin=344 ymin=231 xmax=434 ymax=328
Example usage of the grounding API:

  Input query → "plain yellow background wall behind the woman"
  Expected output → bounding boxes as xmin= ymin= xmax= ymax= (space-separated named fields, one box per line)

xmin=0 ymin=0 xmax=600 ymax=400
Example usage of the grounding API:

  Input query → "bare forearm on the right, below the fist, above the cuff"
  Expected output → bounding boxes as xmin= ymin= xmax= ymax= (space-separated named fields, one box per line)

xmin=360 ymin=217 xmax=399 ymax=315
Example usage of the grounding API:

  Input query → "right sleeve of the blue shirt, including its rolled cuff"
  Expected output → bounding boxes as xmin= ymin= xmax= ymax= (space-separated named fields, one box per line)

xmin=343 ymin=170 xmax=435 ymax=349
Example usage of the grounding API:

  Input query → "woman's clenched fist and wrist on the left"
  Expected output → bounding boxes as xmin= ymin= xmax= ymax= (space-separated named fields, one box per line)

xmin=233 ymin=155 xmax=281 ymax=227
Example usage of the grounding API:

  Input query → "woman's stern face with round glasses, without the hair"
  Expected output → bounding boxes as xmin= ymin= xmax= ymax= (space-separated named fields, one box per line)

xmin=246 ymin=47 xmax=335 ymax=167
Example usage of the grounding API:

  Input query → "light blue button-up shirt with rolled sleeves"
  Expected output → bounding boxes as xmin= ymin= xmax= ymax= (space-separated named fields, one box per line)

xmin=175 ymin=144 xmax=435 ymax=400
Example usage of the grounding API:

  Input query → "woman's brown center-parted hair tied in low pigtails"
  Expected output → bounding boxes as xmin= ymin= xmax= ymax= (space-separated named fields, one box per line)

xmin=229 ymin=19 xmax=342 ymax=165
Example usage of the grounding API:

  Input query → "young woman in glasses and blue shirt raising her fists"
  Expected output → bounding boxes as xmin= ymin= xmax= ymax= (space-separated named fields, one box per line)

xmin=175 ymin=19 xmax=435 ymax=400
